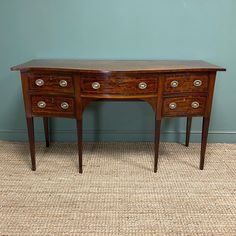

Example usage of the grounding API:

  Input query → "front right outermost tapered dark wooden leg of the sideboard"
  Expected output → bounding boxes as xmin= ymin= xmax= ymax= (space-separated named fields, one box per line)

xmin=200 ymin=117 xmax=210 ymax=170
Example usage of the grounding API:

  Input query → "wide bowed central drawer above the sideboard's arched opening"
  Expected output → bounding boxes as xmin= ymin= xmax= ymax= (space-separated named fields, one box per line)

xmin=81 ymin=76 xmax=157 ymax=95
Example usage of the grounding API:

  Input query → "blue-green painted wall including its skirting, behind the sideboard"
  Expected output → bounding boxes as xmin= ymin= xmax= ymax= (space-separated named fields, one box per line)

xmin=0 ymin=0 xmax=236 ymax=142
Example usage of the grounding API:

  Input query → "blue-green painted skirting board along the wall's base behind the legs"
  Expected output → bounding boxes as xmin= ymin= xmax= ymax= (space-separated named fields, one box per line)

xmin=0 ymin=129 xmax=236 ymax=143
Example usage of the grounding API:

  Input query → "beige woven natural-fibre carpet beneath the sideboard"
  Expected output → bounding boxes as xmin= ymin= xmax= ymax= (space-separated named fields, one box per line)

xmin=0 ymin=142 xmax=236 ymax=236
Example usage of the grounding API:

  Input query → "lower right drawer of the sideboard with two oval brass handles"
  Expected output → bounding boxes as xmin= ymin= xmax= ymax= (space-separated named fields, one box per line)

xmin=162 ymin=96 xmax=206 ymax=116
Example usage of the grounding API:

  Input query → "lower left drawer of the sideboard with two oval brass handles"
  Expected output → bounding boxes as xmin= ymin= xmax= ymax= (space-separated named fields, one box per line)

xmin=31 ymin=96 xmax=75 ymax=116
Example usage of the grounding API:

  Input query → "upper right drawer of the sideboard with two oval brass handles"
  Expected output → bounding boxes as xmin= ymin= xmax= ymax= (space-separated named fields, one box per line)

xmin=164 ymin=73 xmax=209 ymax=93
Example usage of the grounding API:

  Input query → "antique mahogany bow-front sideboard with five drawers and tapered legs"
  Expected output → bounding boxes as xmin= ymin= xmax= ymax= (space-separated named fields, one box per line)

xmin=11 ymin=59 xmax=225 ymax=173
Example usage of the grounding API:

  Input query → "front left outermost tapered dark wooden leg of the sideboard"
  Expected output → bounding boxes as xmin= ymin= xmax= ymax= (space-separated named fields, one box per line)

xmin=26 ymin=117 xmax=36 ymax=171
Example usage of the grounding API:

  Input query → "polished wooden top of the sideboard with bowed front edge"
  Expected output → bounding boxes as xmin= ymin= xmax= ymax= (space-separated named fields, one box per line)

xmin=11 ymin=59 xmax=225 ymax=72
